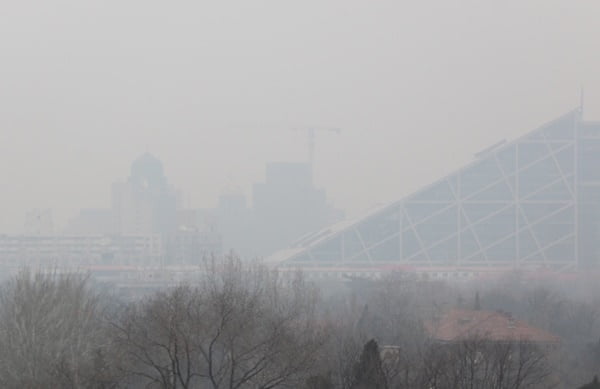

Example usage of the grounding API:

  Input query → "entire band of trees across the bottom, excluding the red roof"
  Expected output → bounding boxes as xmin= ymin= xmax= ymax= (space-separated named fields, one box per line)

xmin=0 ymin=257 xmax=600 ymax=389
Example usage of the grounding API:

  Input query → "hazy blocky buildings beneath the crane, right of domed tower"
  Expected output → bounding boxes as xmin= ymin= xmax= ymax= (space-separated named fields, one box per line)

xmin=212 ymin=162 xmax=343 ymax=258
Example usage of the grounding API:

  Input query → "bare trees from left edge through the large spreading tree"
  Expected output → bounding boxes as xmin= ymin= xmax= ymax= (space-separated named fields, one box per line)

xmin=0 ymin=258 xmax=326 ymax=389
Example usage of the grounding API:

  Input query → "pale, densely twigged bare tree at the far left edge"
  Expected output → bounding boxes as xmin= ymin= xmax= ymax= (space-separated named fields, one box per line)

xmin=0 ymin=270 xmax=113 ymax=388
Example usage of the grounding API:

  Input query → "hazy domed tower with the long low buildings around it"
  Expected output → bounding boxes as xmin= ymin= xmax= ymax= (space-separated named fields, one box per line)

xmin=0 ymin=154 xmax=222 ymax=267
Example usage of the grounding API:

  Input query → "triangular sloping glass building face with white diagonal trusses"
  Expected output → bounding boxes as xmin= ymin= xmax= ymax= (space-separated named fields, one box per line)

xmin=286 ymin=110 xmax=581 ymax=269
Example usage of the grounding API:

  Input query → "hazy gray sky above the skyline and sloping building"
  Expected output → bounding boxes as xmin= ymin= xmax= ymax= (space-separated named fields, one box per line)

xmin=0 ymin=0 xmax=600 ymax=232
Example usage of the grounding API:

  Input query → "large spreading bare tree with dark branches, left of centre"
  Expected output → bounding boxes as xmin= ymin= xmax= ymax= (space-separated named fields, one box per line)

xmin=114 ymin=257 xmax=325 ymax=389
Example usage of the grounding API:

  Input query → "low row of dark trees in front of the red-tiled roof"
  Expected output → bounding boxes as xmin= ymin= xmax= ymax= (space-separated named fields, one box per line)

xmin=332 ymin=338 xmax=558 ymax=389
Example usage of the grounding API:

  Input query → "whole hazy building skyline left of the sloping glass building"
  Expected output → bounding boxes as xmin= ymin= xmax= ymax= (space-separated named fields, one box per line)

xmin=7 ymin=153 xmax=343 ymax=265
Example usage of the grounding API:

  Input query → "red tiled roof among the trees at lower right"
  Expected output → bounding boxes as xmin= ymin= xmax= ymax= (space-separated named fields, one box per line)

xmin=425 ymin=309 xmax=560 ymax=343
